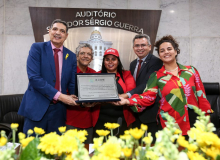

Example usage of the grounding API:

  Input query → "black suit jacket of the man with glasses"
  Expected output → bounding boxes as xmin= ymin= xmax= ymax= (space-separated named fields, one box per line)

xmin=129 ymin=54 xmax=163 ymax=123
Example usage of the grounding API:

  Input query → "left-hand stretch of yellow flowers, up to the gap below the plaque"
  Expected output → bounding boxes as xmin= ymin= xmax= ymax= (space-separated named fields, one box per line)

xmin=0 ymin=124 xmax=89 ymax=160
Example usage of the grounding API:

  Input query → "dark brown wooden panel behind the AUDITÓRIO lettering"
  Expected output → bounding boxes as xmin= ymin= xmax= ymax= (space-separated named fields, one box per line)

xmin=29 ymin=7 xmax=161 ymax=50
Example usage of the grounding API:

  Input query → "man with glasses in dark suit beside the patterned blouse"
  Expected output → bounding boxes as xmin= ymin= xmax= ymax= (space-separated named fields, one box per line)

xmin=123 ymin=34 xmax=163 ymax=140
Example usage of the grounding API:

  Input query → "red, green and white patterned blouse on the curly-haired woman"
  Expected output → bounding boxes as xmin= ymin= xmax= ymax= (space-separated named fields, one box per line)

xmin=129 ymin=64 xmax=213 ymax=135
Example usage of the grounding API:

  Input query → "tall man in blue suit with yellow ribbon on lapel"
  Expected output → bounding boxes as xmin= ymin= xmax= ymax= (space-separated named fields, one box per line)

xmin=18 ymin=19 xmax=77 ymax=133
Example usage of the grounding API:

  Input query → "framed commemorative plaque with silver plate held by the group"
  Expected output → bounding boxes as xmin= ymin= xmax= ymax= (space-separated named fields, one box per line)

xmin=76 ymin=73 xmax=120 ymax=102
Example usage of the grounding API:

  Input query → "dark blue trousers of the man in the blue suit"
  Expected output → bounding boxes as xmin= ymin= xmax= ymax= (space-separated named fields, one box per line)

xmin=23 ymin=102 xmax=66 ymax=134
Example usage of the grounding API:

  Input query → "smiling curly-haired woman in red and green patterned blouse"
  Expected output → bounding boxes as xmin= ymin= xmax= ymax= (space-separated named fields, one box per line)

xmin=115 ymin=35 xmax=212 ymax=135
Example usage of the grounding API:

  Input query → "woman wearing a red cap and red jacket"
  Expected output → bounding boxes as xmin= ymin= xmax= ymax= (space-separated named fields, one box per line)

xmin=92 ymin=48 xmax=136 ymax=137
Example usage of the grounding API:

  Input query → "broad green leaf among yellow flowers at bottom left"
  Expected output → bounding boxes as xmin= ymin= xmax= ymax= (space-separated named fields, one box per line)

xmin=20 ymin=138 xmax=40 ymax=160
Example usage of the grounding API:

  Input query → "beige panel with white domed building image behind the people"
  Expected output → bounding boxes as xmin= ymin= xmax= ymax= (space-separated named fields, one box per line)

xmin=43 ymin=27 xmax=137 ymax=71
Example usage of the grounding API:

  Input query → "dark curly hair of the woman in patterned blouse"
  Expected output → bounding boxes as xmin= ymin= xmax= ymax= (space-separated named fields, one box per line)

xmin=154 ymin=35 xmax=180 ymax=57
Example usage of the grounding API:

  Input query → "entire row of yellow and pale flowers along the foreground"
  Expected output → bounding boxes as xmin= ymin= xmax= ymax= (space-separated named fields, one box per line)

xmin=0 ymin=107 xmax=220 ymax=160
